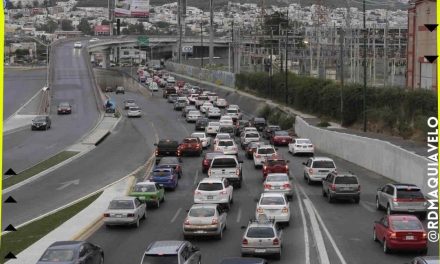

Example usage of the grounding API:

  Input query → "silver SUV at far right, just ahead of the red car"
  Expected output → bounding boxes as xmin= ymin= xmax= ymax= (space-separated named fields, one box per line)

xmin=376 ymin=183 xmax=428 ymax=219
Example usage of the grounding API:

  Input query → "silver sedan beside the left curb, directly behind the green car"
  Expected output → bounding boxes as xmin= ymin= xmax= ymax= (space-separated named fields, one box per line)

xmin=104 ymin=197 xmax=147 ymax=227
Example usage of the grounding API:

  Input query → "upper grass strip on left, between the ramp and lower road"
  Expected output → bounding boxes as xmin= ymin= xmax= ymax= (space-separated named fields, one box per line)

xmin=3 ymin=151 xmax=79 ymax=189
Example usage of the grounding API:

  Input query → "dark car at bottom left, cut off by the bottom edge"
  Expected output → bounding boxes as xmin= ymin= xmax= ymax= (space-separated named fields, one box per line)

xmin=37 ymin=241 xmax=104 ymax=264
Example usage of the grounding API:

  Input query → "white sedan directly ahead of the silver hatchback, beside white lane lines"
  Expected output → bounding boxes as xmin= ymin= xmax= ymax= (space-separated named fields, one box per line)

xmin=255 ymin=193 xmax=290 ymax=225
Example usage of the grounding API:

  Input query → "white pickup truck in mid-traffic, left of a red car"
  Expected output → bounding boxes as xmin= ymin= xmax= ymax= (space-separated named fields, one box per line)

xmin=208 ymin=155 xmax=243 ymax=188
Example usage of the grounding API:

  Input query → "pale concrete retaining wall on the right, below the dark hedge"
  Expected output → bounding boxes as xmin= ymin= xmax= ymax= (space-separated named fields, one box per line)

xmin=295 ymin=116 xmax=429 ymax=194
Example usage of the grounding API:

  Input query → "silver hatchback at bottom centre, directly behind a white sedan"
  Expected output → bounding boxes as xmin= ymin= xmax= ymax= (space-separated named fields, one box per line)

xmin=241 ymin=217 xmax=283 ymax=259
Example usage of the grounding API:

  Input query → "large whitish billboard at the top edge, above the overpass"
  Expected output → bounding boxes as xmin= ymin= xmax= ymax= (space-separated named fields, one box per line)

xmin=115 ymin=0 xmax=150 ymax=17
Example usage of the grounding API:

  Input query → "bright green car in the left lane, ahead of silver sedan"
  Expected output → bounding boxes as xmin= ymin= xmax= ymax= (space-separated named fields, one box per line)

xmin=130 ymin=182 xmax=165 ymax=208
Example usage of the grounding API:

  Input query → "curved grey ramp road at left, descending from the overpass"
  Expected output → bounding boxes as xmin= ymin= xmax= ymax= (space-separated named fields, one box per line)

xmin=3 ymin=42 xmax=99 ymax=172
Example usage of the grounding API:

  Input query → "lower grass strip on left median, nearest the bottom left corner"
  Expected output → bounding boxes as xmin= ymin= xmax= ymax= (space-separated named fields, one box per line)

xmin=0 ymin=192 xmax=102 ymax=258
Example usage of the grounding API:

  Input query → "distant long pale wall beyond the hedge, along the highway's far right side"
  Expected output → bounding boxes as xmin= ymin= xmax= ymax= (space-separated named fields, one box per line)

xmin=165 ymin=62 xmax=235 ymax=88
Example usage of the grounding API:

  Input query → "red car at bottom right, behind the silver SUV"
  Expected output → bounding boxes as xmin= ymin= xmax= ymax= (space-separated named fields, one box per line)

xmin=373 ymin=215 xmax=428 ymax=254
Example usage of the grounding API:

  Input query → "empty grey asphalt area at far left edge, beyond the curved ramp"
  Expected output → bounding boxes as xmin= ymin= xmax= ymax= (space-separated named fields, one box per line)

xmin=3 ymin=68 xmax=46 ymax=120
